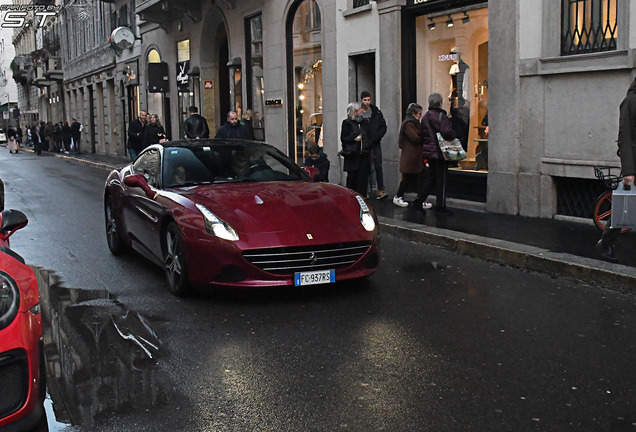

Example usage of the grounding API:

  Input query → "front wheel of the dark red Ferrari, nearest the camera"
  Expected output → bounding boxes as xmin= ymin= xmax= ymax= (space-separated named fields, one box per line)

xmin=163 ymin=222 xmax=190 ymax=297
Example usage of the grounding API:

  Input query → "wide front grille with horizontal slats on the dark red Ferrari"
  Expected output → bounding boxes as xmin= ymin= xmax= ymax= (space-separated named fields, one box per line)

xmin=243 ymin=242 xmax=371 ymax=275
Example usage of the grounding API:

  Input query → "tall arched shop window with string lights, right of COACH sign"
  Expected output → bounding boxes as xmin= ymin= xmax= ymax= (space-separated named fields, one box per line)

xmin=288 ymin=0 xmax=322 ymax=163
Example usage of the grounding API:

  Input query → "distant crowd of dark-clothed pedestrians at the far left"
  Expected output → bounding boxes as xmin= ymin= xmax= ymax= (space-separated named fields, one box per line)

xmin=7 ymin=118 xmax=84 ymax=156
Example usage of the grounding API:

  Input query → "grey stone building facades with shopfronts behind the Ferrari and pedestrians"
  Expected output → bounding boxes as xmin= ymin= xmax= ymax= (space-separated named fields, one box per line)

xmin=46 ymin=0 xmax=636 ymax=221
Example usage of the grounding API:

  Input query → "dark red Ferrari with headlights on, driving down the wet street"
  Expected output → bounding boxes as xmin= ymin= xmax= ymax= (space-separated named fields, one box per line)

xmin=104 ymin=139 xmax=380 ymax=295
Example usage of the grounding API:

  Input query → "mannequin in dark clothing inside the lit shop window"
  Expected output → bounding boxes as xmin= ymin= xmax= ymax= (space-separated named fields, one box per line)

xmin=449 ymin=48 xmax=471 ymax=151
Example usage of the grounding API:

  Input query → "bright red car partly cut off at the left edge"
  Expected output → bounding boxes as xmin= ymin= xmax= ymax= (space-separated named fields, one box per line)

xmin=0 ymin=186 xmax=46 ymax=432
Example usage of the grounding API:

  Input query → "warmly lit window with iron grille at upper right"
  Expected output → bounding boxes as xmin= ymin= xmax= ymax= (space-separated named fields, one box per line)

xmin=561 ymin=0 xmax=619 ymax=55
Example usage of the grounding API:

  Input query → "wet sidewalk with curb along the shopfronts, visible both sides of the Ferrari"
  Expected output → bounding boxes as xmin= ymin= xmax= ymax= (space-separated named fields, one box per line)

xmin=27 ymin=149 xmax=636 ymax=293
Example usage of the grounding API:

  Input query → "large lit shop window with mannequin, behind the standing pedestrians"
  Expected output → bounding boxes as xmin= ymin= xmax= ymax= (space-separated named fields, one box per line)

xmin=415 ymin=8 xmax=489 ymax=171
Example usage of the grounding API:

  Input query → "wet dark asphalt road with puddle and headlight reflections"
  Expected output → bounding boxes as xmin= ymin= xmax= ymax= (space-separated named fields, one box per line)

xmin=0 ymin=148 xmax=636 ymax=431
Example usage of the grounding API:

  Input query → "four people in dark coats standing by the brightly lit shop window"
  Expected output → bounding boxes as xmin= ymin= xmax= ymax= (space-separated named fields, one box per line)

xmin=340 ymin=91 xmax=456 ymax=213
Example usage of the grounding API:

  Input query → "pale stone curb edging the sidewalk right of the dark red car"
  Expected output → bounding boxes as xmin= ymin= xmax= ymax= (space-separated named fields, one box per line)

xmin=378 ymin=217 xmax=636 ymax=294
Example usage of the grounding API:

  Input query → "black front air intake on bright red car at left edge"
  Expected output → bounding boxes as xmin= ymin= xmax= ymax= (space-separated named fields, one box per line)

xmin=0 ymin=350 xmax=29 ymax=418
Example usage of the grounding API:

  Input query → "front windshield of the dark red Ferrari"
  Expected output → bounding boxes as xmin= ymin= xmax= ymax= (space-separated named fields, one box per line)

xmin=162 ymin=142 xmax=308 ymax=187
